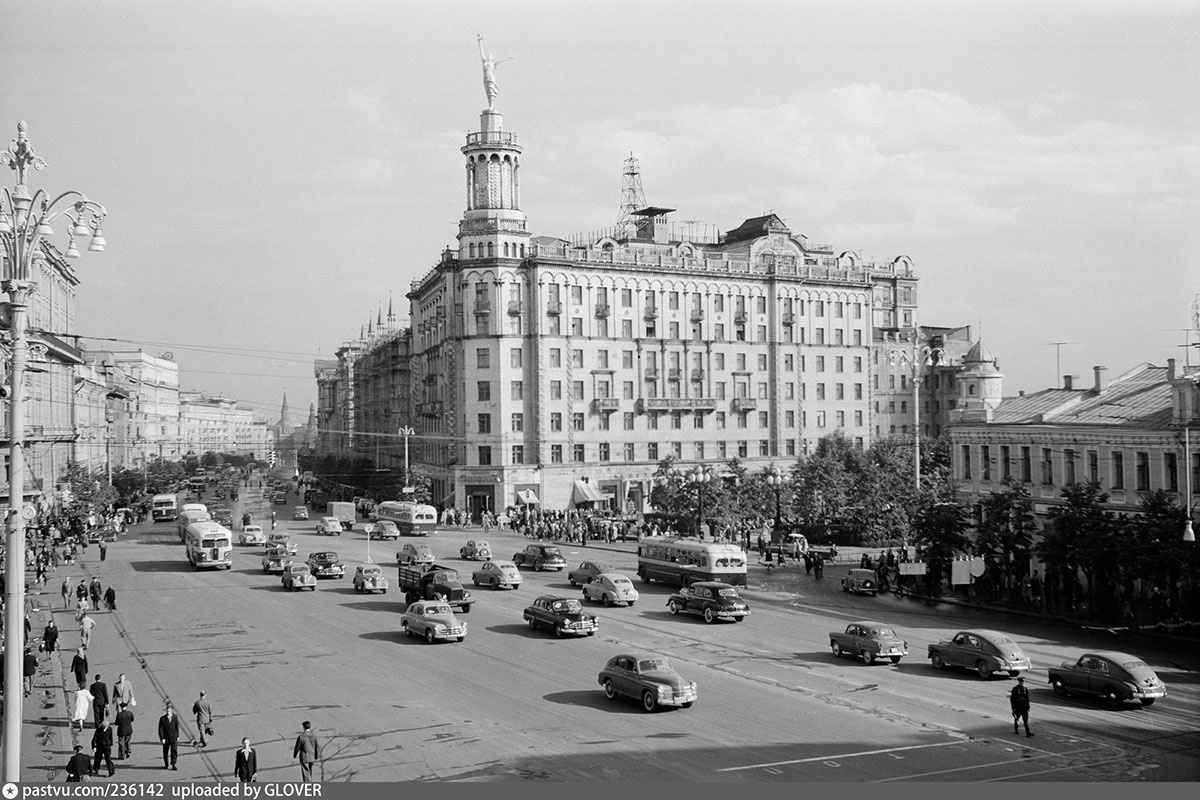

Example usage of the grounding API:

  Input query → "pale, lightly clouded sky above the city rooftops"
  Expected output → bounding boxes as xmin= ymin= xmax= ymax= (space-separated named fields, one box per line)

xmin=0 ymin=0 xmax=1200 ymax=423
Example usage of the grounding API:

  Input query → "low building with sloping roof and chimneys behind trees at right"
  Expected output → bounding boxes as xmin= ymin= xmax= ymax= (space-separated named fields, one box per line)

xmin=949 ymin=352 xmax=1200 ymax=527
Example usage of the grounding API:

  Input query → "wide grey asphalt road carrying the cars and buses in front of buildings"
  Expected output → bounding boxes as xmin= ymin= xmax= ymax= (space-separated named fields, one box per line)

xmin=35 ymin=491 xmax=1200 ymax=782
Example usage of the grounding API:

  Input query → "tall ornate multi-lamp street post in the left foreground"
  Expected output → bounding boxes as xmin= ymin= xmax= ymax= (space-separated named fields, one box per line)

xmin=0 ymin=121 xmax=107 ymax=783
